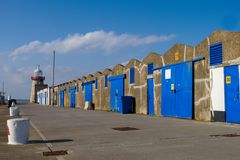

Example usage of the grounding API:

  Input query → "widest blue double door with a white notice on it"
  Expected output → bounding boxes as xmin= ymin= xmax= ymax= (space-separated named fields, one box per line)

xmin=161 ymin=62 xmax=193 ymax=119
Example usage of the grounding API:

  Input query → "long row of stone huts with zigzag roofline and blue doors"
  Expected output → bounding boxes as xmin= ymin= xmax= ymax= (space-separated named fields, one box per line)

xmin=38 ymin=30 xmax=240 ymax=123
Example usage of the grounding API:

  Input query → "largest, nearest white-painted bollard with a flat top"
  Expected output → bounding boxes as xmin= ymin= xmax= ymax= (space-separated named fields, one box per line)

xmin=7 ymin=118 xmax=29 ymax=144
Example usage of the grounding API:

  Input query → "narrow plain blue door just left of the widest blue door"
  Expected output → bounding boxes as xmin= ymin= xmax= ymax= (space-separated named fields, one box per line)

xmin=147 ymin=78 xmax=154 ymax=115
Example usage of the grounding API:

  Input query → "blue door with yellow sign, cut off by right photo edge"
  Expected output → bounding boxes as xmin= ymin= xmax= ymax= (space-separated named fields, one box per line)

xmin=224 ymin=65 xmax=240 ymax=123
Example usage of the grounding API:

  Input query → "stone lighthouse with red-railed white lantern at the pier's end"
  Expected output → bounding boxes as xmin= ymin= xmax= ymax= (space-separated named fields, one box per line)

xmin=30 ymin=65 xmax=48 ymax=103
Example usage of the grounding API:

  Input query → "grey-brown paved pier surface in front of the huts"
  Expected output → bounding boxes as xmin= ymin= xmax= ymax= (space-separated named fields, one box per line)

xmin=0 ymin=105 xmax=240 ymax=160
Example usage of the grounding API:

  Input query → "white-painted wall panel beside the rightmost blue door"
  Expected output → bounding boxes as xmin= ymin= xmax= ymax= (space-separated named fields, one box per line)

xmin=210 ymin=67 xmax=225 ymax=111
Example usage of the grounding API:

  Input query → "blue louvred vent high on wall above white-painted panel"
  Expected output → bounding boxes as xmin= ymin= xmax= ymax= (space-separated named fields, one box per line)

xmin=209 ymin=43 xmax=222 ymax=66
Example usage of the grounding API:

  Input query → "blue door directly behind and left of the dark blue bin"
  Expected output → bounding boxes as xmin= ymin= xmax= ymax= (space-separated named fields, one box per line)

xmin=109 ymin=74 xmax=126 ymax=112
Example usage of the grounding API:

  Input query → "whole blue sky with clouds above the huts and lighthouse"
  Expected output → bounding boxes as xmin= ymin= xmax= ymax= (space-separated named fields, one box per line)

xmin=0 ymin=0 xmax=240 ymax=98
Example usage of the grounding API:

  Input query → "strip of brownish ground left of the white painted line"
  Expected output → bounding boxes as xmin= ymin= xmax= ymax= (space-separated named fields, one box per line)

xmin=0 ymin=106 xmax=56 ymax=160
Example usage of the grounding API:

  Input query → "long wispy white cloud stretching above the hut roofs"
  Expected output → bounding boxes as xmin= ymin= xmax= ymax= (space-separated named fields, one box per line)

xmin=10 ymin=31 xmax=175 ymax=59
